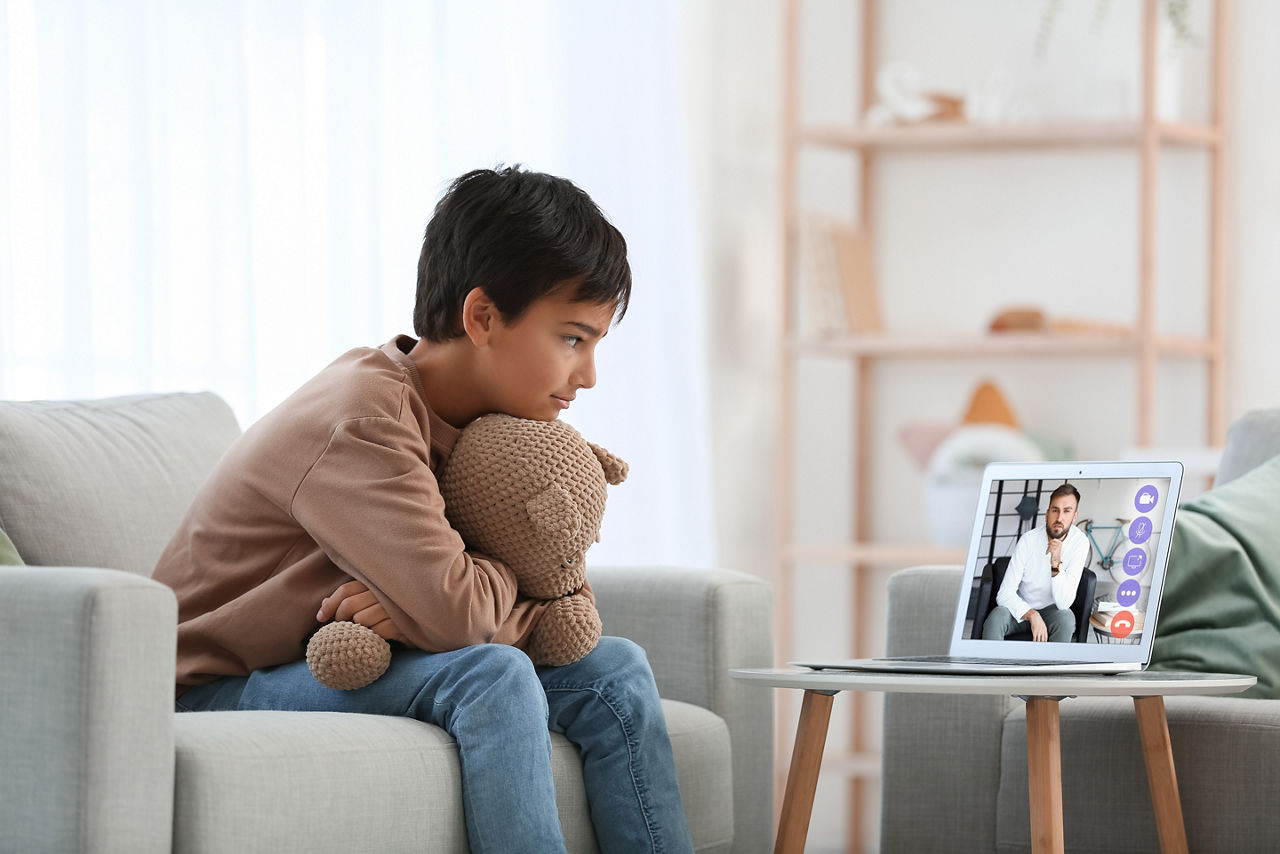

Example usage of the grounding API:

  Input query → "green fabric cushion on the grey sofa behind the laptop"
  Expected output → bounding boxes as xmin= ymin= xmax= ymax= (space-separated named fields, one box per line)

xmin=1151 ymin=456 xmax=1280 ymax=699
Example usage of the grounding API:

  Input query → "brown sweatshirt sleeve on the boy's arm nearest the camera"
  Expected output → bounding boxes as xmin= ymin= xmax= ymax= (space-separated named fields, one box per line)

xmin=291 ymin=416 xmax=516 ymax=652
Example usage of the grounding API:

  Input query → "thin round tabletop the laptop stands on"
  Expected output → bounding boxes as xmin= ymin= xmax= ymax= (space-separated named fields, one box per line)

xmin=730 ymin=667 xmax=1258 ymax=697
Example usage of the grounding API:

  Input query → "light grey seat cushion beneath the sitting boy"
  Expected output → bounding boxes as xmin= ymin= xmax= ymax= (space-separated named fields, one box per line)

xmin=174 ymin=700 xmax=733 ymax=854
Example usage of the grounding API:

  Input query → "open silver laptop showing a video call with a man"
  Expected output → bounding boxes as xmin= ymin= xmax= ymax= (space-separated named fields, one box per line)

xmin=790 ymin=462 xmax=1183 ymax=675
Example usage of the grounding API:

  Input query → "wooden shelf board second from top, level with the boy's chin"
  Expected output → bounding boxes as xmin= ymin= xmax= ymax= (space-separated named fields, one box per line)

xmin=787 ymin=332 xmax=1217 ymax=359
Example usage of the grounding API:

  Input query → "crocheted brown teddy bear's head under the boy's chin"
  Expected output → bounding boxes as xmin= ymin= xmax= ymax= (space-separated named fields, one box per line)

xmin=440 ymin=415 xmax=627 ymax=599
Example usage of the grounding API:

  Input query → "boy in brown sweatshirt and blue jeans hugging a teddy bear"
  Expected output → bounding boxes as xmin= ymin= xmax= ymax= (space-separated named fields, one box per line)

xmin=155 ymin=168 xmax=692 ymax=853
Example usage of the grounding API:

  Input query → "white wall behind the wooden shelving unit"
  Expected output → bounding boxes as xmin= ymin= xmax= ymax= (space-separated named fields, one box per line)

xmin=689 ymin=0 xmax=1280 ymax=850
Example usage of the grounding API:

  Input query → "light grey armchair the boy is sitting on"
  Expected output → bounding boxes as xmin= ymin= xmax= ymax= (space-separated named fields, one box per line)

xmin=0 ymin=393 xmax=773 ymax=854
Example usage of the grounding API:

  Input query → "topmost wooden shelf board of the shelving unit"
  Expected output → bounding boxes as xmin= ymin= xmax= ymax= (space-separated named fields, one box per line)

xmin=796 ymin=120 xmax=1222 ymax=151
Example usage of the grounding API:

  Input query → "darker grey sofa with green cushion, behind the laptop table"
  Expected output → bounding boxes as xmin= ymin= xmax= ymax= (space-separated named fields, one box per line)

xmin=881 ymin=410 xmax=1280 ymax=854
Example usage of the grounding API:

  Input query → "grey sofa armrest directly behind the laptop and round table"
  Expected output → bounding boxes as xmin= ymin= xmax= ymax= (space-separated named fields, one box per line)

xmin=881 ymin=566 xmax=1014 ymax=851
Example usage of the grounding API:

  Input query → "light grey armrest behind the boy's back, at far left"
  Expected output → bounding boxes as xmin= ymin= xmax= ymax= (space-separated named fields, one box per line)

xmin=0 ymin=566 xmax=178 ymax=853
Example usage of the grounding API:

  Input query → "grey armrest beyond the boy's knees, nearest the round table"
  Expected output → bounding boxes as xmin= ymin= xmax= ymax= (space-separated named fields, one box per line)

xmin=590 ymin=567 xmax=773 ymax=850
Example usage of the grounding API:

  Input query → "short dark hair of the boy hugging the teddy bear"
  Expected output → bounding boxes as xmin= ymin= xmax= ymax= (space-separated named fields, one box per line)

xmin=413 ymin=165 xmax=631 ymax=341
